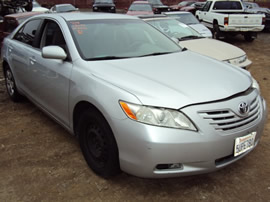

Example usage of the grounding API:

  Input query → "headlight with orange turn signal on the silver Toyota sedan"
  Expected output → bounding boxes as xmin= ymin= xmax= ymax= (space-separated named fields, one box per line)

xmin=120 ymin=101 xmax=197 ymax=131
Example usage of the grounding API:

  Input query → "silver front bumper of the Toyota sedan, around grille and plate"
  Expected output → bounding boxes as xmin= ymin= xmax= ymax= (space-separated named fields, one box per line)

xmin=112 ymin=90 xmax=266 ymax=178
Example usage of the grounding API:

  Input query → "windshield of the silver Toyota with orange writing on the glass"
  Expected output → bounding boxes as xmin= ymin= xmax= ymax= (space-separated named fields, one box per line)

xmin=68 ymin=19 xmax=181 ymax=60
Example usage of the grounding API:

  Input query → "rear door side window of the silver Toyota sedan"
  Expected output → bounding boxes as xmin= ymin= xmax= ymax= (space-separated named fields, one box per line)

xmin=14 ymin=20 xmax=41 ymax=46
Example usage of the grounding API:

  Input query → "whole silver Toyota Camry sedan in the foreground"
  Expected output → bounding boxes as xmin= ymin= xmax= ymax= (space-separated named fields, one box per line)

xmin=2 ymin=13 xmax=266 ymax=178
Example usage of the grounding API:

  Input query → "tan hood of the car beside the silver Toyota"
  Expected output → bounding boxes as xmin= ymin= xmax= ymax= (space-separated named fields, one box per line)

xmin=179 ymin=38 xmax=246 ymax=61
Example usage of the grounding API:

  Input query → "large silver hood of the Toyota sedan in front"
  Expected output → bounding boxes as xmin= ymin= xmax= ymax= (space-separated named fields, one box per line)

xmin=87 ymin=51 xmax=252 ymax=109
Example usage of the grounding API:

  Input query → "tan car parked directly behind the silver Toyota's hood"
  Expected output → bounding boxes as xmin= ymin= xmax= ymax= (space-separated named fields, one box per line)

xmin=143 ymin=16 xmax=252 ymax=69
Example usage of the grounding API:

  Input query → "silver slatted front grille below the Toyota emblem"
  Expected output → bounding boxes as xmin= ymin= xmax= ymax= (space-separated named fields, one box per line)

xmin=199 ymin=97 xmax=260 ymax=131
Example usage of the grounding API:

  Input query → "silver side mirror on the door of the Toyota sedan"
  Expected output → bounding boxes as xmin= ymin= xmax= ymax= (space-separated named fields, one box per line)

xmin=41 ymin=46 xmax=67 ymax=60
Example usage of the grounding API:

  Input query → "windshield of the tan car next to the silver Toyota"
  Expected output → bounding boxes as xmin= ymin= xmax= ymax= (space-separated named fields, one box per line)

xmin=147 ymin=19 xmax=202 ymax=40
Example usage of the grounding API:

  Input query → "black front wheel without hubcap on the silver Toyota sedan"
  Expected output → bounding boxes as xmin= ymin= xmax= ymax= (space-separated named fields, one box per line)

xmin=76 ymin=107 xmax=120 ymax=178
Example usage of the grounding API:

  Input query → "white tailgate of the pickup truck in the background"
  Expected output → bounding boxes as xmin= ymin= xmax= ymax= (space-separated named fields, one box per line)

xmin=229 ymin=14 xmax=263 ymax=27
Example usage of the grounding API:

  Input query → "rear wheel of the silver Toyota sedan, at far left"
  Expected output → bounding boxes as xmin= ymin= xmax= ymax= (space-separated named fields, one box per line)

xmin=4 ymin=66 xmax=23 ymax=102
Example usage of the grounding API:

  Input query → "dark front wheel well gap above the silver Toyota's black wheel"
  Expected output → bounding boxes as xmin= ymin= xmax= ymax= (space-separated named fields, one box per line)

xmin=73 ymin=101 xmax=102 ymax=136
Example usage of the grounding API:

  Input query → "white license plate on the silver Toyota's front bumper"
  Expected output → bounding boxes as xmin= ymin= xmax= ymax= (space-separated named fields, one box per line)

xmin=234 ymin=132 xmax=256 ymax=156
